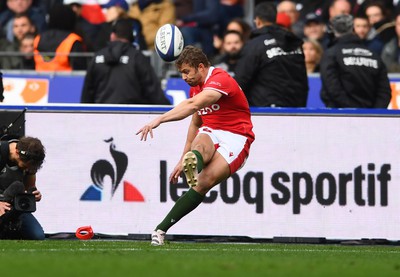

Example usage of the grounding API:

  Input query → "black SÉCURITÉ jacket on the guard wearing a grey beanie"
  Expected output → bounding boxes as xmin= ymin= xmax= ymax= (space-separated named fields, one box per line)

xmin=320 ymin=34 xmax=391 ymax=108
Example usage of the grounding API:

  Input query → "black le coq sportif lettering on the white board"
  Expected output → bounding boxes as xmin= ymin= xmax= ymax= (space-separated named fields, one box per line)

xmin=160 ymin=161 xmax=391 ymax=214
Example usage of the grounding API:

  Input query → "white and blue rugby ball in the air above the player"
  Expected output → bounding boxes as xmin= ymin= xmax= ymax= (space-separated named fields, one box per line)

xmin=154 ymin=24 xmax=184 ymax=62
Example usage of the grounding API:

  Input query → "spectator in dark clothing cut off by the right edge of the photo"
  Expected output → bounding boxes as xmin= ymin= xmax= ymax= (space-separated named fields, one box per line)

xmin=382 ymin=14 xmax=400 ymax=72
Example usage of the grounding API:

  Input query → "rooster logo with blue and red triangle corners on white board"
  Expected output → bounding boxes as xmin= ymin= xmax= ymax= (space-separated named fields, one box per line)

xmin=80 ymin=138 xmax=144 ymax=202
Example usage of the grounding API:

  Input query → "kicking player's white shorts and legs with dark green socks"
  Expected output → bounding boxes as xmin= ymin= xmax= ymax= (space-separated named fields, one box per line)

xmin=152 ymin=128 xmax=250 ymax=245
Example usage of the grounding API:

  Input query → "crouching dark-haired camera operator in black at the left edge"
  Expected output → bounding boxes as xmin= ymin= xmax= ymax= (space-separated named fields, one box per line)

xmin=0 ymin=137 xmax=45 ymax=240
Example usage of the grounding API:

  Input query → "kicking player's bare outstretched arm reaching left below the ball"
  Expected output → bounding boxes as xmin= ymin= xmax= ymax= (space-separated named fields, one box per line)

xmin=136 ymin=89 xmax=222 ymax=140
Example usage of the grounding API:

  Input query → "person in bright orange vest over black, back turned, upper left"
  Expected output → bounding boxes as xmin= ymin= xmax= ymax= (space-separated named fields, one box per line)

xmin=34 ymin=5 xmax=86 ymax=71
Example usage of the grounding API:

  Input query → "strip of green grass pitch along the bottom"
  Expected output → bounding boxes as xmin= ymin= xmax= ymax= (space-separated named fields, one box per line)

xmin=0 ymin=239 xmax=400 ymax=277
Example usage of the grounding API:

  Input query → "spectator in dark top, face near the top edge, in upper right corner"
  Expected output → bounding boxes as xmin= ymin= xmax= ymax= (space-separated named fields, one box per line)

xmin=365 ymin=2 xmax=396 ymax=44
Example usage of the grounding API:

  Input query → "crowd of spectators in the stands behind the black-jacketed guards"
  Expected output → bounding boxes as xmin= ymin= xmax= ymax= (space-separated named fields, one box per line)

xmin=0 ymin=0 xmax=400 ymax=106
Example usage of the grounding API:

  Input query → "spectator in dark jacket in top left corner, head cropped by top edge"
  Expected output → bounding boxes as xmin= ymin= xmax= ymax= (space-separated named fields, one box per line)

xmin=0 ymin=0 xmax=47 ymax=42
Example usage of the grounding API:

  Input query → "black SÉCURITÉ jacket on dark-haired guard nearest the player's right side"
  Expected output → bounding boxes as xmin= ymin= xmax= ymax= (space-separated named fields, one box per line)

xmin=235 ymin=25 xmax=308 ymax=107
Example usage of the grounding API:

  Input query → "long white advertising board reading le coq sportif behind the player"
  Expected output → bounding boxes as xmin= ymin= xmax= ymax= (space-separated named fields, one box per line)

xmin=25 ymin=110 xmax=400 ymax=240
